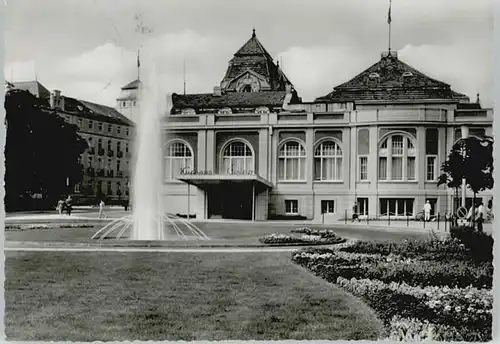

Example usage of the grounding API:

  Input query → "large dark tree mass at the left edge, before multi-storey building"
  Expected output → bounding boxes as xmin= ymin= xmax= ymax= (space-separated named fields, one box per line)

xmin=5 ymin=89 xmax=88 ymax=211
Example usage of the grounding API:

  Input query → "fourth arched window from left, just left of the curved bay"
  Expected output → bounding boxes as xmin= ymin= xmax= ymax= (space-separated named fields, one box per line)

xmin=314 ymin=140 xmax=342 ymax=181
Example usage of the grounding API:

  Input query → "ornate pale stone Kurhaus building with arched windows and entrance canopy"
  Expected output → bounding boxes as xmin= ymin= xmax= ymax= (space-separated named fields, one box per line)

xmin=160 ymin=31 xmax=493 ymax=220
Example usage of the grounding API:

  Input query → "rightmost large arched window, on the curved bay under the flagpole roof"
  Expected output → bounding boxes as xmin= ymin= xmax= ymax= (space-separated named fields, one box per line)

xmin=378 ymin=134 xmax=416 ymax=180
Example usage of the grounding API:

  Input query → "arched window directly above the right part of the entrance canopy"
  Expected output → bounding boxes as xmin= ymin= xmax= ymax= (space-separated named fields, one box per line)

xmin=220 ymin=141 xmax=254 ymax=174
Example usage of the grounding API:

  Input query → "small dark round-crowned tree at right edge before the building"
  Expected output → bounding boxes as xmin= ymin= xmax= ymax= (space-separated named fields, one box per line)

xmin=438 ymin=136 xmax=494 ymax=226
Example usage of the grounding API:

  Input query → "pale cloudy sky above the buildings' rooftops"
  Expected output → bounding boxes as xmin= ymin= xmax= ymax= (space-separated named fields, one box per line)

xmin=4 ymin=0 xmax=493 ymax=106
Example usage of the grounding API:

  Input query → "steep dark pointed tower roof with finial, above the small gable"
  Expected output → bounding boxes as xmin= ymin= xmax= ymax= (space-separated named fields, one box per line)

xmin=221 ymin=30 xmax=292 ymax=91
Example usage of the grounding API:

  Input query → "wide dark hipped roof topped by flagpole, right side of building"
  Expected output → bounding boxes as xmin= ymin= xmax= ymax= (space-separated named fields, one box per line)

xmin=316 ymin=52 xmax=468 ymax=102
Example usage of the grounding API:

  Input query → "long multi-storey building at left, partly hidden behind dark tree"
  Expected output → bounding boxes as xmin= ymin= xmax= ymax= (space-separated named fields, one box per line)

xmin=11 ymin=81 xmax=134 ymax=204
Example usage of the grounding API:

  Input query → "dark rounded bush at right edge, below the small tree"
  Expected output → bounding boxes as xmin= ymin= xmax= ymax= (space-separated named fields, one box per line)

xmin=450 ymin=226 xmax=493 ymax=262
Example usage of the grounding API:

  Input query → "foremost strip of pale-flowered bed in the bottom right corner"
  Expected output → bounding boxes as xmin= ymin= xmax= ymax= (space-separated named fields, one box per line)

xmin=337 ymin=277 xmax=493 ymax=340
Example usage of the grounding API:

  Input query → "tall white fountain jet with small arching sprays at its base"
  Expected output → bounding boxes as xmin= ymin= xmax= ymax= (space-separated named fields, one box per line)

xmin=92 ymin=49 xmax=208 ymax=240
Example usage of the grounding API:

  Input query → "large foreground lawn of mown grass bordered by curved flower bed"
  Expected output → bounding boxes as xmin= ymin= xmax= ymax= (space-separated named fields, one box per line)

xmin=5 ymin=252 xmax=382 ymax=341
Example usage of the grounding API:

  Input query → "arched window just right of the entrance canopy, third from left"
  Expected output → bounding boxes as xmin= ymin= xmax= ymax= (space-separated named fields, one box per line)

xmin=278 ymin=141 xmax=306 ymax=180
